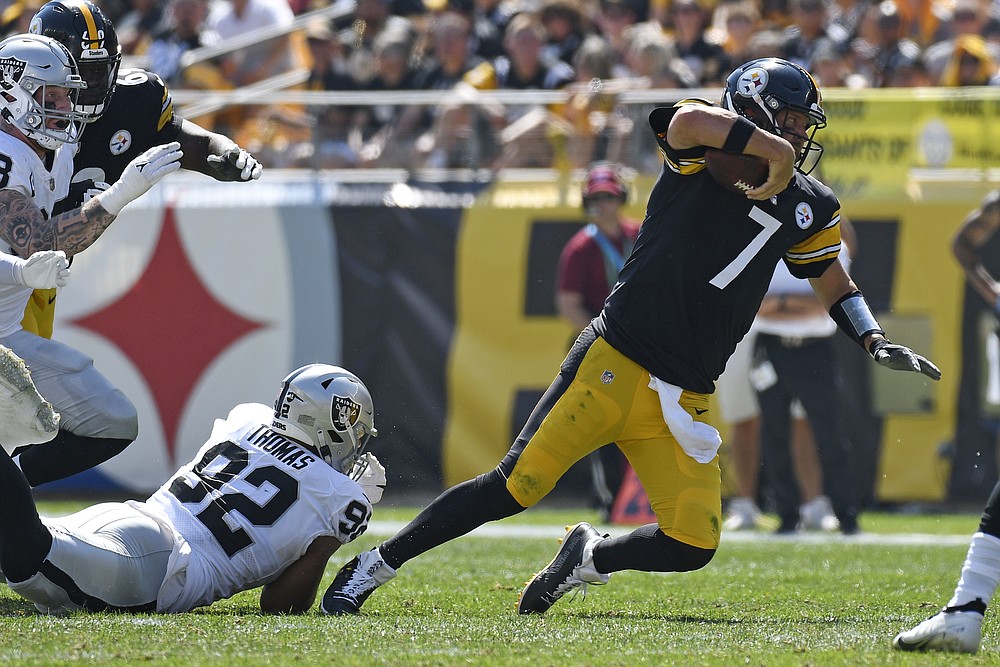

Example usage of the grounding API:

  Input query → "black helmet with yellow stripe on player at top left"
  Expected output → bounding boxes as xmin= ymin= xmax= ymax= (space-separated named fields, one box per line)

xmin=28 ymin=0 xmax=122 ymax=122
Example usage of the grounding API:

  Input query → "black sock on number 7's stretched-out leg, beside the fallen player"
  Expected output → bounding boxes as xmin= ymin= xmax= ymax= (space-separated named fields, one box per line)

xmin=379 ymin=470 xmax=526 ymax=568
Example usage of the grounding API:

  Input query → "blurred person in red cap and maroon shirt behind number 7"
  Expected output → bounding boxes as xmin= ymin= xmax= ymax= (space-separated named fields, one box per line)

xmin=556 ymin=163 xmax=639 ymax=521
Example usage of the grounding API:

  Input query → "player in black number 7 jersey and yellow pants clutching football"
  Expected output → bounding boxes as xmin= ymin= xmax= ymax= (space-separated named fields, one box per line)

xmin=322 ymin=58 xmax=941 ymax=614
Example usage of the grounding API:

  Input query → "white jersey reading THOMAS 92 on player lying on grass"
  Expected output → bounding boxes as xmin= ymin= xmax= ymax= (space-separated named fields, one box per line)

xmin=144 ymin=403 xmax=372 ymax=612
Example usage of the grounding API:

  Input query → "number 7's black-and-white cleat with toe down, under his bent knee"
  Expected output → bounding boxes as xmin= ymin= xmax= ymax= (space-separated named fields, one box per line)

xmin=517 ymin=521 xmax=611 ymax=614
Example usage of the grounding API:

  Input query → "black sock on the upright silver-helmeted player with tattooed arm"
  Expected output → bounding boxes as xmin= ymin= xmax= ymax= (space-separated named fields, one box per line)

xmin=19 ymin=430 xmax=132 ymax=486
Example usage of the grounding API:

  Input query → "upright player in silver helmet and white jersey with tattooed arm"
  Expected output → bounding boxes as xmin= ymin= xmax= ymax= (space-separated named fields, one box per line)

xmin=0 ymin=35 xmax=182 ymax=485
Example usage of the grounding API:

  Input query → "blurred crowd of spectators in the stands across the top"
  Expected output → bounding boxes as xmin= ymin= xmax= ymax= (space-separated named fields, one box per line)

xmin=0 ymin=0 xmax=1000 ymax=168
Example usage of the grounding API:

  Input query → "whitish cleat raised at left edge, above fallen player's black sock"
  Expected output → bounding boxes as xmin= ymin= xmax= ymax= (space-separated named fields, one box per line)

xmin=0 ymin=345 xmax=59 ymax=453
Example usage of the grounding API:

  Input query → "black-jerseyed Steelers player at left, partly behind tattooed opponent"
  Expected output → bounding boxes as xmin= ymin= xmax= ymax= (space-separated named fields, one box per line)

xmin=24 ymin=0 xmax=262 ymax=338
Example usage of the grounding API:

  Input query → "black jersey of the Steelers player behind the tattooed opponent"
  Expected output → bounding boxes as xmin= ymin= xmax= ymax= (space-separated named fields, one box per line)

xmin=73 ymin=69 xmax=180 ymax=188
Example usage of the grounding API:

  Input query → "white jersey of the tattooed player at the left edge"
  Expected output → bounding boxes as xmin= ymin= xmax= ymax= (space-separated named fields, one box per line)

xmin=0 ymin=132 xmax=73 ymax=338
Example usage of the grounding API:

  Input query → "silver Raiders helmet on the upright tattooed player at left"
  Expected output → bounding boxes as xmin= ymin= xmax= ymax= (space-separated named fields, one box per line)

xmin=0 ymin=35 xmax=86 ymax=150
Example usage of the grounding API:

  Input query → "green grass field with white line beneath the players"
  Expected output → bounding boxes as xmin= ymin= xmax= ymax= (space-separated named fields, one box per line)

xmin=0 ymin=504 xmax=1000 ymax=667
